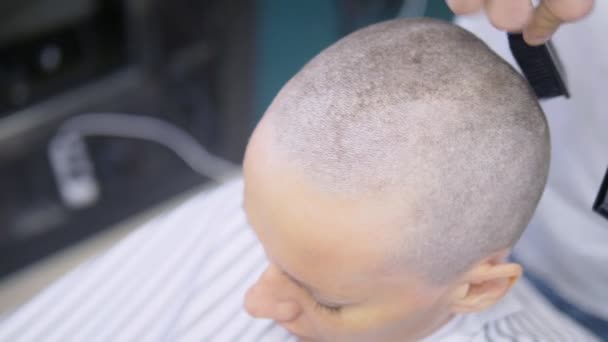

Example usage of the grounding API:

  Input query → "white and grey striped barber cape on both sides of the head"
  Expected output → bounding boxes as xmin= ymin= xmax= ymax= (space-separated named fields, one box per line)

xmin=0 ymin=180 xmax=593 ymax=342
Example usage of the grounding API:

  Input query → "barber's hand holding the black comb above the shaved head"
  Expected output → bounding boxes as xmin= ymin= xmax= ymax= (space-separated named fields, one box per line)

xmin=446 ymin=0 xmax=592 ymax=45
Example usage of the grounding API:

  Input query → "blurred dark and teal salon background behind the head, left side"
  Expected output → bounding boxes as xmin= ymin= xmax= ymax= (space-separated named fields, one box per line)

xmin=0 ymin=0 xmax=451 ymax=314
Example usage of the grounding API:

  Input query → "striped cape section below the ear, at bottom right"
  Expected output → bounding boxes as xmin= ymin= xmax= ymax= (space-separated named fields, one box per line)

xmin=473 ymin=280 xmax=599 ymax=342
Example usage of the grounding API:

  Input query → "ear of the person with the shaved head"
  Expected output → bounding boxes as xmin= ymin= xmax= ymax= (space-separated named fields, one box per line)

xmin=452 ymin=259 xmax=522 ymax=313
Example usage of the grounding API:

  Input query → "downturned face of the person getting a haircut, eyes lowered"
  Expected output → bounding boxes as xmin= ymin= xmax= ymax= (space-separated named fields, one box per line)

xmin=244 ymin=127 xmax=460 ymax=342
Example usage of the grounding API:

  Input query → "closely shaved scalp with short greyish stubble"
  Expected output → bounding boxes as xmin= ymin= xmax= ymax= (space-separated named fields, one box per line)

xmin=262 ymin=19 xmax=550 ymax=282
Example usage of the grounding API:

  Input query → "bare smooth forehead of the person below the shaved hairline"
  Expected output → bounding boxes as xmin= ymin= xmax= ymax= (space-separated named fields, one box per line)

xmin=244 ymin=143 xmax=422 ymax=296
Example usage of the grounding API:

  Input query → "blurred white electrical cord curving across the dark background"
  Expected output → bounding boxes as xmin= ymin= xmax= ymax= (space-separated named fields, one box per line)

xmin=48 ymin=113 xmax=239 ymax=208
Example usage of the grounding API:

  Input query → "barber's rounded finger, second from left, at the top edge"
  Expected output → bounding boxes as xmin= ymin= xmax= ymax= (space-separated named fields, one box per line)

xmin=486 ymin=0 xmax=534 ymax=32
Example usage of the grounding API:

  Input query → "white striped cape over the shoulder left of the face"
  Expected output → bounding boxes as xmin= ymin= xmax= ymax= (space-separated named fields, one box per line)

xmin=0 ymin=179 xmax=258 ymax=341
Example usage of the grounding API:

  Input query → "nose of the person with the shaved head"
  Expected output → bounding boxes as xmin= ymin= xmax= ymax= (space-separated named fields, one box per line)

xmin=245 ymin=265 xmax=302 ymax=323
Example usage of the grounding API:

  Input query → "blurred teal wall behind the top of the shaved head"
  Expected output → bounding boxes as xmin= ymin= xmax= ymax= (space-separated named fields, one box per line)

xmin=254 ymin=0 xmax=452 ymax=122
